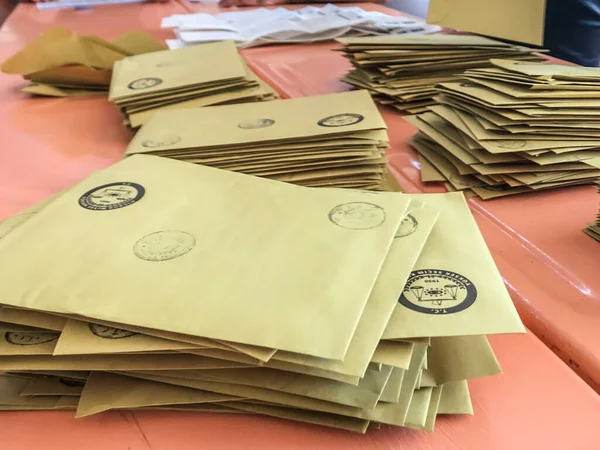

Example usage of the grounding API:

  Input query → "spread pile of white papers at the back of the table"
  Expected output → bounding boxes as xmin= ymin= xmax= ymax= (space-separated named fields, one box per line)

xmin=161 ymin=4 xmax=441 ymax=48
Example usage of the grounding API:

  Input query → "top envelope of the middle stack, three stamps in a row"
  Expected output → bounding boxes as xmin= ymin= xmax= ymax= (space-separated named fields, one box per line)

xmin=127 ymin=91 xmax=386 ymax=155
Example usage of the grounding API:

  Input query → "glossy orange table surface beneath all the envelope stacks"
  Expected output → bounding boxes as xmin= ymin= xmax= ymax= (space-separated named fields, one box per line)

xmin=0 ymin=2 xmax=600 ymax=450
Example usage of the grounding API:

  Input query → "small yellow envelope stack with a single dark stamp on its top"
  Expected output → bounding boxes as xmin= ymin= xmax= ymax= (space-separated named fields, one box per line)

xmin=109 ymin=41 xmax=277 ymax=129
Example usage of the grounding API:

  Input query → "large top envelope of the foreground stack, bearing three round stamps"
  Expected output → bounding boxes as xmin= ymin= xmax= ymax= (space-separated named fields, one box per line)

xmin=0 ymin=156 xmax=409 ymax=360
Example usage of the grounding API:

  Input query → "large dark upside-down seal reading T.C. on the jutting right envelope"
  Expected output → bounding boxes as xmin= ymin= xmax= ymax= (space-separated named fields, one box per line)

xmin=398 ymin=269 xmax=477 ymax=314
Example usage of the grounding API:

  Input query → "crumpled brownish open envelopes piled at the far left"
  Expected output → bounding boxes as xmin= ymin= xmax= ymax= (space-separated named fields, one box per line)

xmin=2 ymin=28 xmax=166 ymax=97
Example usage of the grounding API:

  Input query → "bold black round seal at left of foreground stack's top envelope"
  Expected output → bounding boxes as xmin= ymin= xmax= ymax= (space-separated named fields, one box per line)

xmin=79 ymin=181 xmax=146 ymax=211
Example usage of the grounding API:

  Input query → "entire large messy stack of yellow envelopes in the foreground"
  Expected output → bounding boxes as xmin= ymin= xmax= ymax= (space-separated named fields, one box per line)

xmin=0 ymin=155 xmax=524 ymax=432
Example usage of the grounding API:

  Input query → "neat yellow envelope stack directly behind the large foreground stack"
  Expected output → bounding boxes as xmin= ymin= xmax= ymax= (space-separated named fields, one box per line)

xmin=126 ymin=91 xmax=388 ymax=189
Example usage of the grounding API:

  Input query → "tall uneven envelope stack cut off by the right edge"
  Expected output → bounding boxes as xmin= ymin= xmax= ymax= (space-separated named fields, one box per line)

xmin=407 ymin=59 xmax=600 ymax=199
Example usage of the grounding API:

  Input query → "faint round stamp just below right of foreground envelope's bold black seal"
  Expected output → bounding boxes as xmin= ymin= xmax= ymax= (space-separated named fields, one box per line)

xmin=133 ymin=230 xmax=196 ymax=261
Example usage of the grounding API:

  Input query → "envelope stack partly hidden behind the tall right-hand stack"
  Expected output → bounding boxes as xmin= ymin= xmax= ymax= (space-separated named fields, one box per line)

xmin=338 ymin=34 xmax=542 ymax=114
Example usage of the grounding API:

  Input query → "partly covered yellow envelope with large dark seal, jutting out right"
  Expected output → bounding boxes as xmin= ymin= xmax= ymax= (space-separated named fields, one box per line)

xmin=383 ymin=193 xmax=525 ymax=339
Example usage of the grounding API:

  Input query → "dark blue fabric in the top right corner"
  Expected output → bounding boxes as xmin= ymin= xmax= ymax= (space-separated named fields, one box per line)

xmin=544 ymin=0 xmax=600 ymax=67
